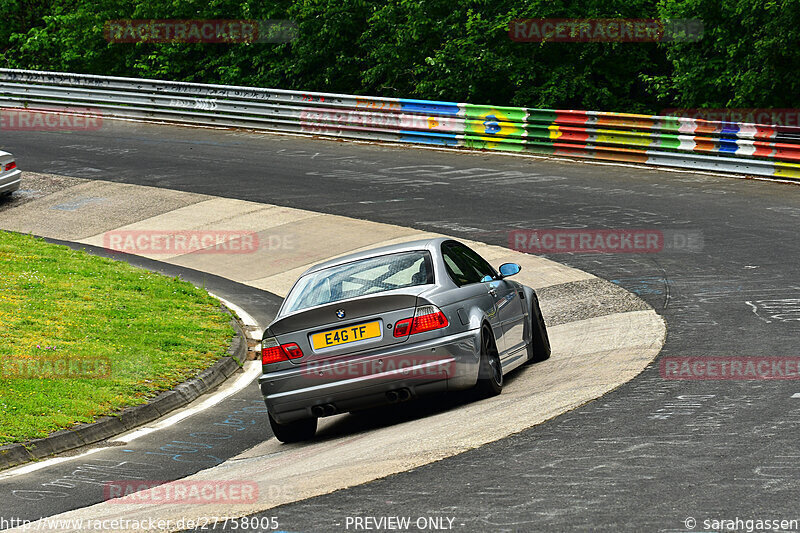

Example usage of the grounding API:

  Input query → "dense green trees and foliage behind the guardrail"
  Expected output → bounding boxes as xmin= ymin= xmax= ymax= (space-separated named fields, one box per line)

xmin=0 ymin=0 xmax=800 ymax=112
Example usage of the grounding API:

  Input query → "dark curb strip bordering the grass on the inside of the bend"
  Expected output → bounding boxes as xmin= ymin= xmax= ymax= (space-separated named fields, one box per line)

xmin=0 ymin=316 xmax=247 ymax=470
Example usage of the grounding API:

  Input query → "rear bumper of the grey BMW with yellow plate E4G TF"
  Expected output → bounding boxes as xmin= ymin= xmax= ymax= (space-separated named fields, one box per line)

xmin=258 ymin=329 xmax=480 ymax=423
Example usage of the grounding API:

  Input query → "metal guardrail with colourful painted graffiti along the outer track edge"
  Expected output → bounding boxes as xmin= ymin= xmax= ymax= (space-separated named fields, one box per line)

xmin=0 ymin=69 xmax=800 ymax=179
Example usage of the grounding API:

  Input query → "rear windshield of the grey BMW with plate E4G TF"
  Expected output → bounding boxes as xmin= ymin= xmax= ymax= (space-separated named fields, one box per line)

xmin=281 ymin=251 xmax=433 ymax=315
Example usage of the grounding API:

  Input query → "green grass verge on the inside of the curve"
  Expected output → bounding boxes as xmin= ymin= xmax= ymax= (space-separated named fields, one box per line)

xmin=0 ymin=231 xmax=235 ymax=444
